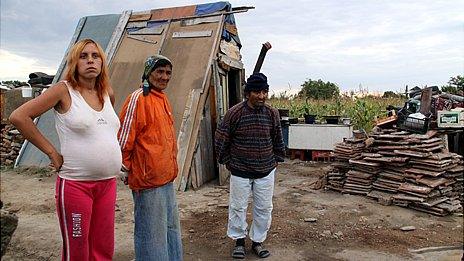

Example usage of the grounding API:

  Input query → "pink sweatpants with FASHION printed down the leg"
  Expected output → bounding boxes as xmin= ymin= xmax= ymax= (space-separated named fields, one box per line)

xmin=55 ymin=176 xmax=116 ymax=261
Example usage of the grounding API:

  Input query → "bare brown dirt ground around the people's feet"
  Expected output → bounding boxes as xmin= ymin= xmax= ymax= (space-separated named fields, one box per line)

xmin=1 ymin=160 xmax=463 ymax=260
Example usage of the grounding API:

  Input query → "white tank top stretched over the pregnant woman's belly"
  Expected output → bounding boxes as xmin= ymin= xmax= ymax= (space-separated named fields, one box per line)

xmin=54 ymin=81 xmax=122 ymax=180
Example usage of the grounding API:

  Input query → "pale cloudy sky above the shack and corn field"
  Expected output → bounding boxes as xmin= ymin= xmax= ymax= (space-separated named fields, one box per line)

xmin=0 ymin=0 xmax=464 ymax=94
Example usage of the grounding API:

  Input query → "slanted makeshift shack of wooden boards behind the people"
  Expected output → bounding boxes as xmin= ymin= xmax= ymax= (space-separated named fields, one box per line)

xmin=15 ymin=2 xmax=253 ymax=191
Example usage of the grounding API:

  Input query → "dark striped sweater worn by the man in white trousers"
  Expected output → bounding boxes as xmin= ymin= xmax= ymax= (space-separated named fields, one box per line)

xmin=215 ymin=101 xmax=285 ymax=179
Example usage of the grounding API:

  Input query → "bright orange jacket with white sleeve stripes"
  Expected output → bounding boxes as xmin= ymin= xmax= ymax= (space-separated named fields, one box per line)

xmin=118 ymin=88 xmax=178 ymax=191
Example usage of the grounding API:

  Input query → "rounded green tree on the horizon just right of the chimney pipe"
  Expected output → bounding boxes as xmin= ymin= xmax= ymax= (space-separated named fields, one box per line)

xmin=298 ymin=79 xmax=340 ymax=99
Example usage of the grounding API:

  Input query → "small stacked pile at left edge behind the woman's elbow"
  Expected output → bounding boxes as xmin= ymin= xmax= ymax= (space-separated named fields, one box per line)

xmin=0 ymin=124 xmax=24 ymax=165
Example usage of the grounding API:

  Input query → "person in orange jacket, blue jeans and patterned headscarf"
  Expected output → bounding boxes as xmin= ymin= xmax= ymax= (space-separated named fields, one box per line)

xmin=118 ymin=55 xmax=182 ymax=261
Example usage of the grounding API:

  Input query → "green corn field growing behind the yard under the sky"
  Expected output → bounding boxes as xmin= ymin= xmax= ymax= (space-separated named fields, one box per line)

xmin=269 ymin=97 xmax=405 ymax=131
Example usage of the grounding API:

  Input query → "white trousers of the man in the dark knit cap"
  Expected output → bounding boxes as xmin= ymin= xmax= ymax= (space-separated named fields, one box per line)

xmin=227 ymin=169 xmax=275 ymax=243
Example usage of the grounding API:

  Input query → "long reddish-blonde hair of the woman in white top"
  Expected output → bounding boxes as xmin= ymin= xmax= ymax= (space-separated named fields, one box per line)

xmin=64 ymin=39 xmax=109 ymax=104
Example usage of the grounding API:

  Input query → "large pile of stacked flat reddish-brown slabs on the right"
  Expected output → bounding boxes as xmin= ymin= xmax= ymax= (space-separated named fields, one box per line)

xmin=326 ymin=129 xmax=464 ymax=216
